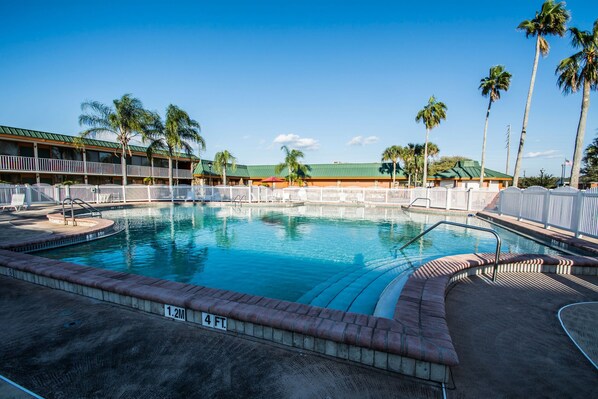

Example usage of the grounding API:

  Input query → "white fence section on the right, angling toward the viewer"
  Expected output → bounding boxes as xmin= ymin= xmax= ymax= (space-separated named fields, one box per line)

xmin=498 ymin=187 xmax=598 ymax=238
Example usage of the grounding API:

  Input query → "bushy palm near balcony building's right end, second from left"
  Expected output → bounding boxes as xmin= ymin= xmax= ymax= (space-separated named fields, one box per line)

xmin=147 ymin=104 xmax=206 ymax=187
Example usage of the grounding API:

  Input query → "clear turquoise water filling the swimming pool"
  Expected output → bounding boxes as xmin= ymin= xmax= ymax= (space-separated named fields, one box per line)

xmin=39 ymin=205 xmax=568 ymax=314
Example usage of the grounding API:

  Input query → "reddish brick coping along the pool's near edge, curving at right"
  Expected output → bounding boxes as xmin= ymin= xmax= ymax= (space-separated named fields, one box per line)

xmin=0 ymin=219 xmax=598 ymax=382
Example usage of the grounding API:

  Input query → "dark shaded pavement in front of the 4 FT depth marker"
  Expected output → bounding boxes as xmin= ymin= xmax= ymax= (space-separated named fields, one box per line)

xmin=0 ymin=277 xmax=442 ymax=399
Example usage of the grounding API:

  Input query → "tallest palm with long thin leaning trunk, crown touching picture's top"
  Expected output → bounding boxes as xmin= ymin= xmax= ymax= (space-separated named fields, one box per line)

xmin=513 ymin=0 xmax=571 ymax=187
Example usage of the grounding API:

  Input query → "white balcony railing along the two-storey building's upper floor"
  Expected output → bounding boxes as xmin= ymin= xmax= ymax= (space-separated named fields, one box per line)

xmin=0 ymin=155 xmax=192 ymax=179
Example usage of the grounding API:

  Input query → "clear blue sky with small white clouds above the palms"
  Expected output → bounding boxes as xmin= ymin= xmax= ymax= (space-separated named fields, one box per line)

xmin=0 ymin=0 xmax=598 ymax=176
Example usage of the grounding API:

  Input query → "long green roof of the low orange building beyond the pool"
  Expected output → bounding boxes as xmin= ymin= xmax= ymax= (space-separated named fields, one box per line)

xmin=193 ymin=160 xmax=405 ymax=179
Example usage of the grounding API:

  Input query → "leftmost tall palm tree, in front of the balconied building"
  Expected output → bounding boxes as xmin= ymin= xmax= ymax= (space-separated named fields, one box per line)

xmin=79 ymin=94 xmax=155 ymax=185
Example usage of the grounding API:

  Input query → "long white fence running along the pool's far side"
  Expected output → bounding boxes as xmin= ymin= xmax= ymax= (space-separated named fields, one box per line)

xmin=0 ymin=184 xmax=498 ymax=211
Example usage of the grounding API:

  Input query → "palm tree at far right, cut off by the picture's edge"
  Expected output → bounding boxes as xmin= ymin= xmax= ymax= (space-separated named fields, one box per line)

xmin=556 ymin=20 xmax=598 ymax=188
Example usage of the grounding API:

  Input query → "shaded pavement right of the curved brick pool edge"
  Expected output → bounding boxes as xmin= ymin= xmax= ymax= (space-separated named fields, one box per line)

xmin=446 ymin=273 xmax=598 ymax=398
